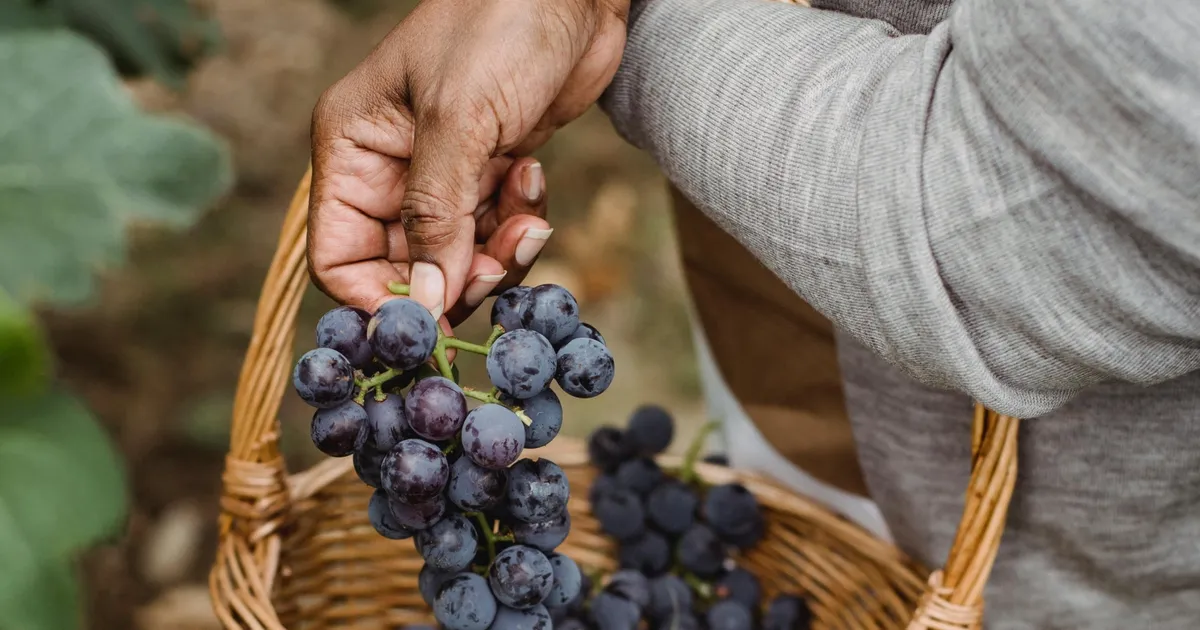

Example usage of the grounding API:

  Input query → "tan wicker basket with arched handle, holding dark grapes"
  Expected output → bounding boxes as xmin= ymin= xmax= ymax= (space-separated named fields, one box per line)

xmin=209 ymin=166 xmax=1018 ymax=630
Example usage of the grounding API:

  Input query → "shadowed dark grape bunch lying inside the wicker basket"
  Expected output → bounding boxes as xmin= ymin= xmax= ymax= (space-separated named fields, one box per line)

xmin=564 ymin=406 xmax=812 ymax=630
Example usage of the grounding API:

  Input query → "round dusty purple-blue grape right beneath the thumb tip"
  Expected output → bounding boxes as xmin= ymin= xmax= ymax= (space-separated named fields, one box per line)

xmin=367 ymin=298 xmax=438 ymax=370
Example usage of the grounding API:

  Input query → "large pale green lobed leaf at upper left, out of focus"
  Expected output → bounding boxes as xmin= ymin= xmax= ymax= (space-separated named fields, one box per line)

xmin=0 ymin=31 xmax=233 ymax=302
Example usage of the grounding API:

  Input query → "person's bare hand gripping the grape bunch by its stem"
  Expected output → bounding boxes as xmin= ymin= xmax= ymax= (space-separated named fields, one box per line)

xmin=308 ymin=0 xmax=628 ymax=318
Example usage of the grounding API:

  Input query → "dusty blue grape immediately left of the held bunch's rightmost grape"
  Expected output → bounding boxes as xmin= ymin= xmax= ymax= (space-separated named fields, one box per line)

xmin=487 ymin=330 xmax=558 ymax=400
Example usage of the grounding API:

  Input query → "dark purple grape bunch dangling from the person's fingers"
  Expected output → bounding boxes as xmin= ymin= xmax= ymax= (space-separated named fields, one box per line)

xmin=293 ymin=284 xmax=613 ymax=630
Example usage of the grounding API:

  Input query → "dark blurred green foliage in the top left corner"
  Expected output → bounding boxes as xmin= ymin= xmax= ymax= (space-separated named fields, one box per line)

xmin=0 ymin=0 xmax=221 ymax=88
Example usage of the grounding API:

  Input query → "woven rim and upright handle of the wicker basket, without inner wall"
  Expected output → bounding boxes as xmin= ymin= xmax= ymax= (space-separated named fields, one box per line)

xmin=209 ymin=166 xmax=1019 ymax=630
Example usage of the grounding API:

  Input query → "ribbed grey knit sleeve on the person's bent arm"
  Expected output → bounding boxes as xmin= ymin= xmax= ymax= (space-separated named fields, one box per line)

xmin=601 ymin=0 xmax=1200 ymax=418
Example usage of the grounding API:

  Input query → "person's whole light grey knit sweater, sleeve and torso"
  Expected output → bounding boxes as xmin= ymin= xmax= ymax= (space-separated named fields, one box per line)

xmin=602 ymin=0 xmax=1200 ymax=630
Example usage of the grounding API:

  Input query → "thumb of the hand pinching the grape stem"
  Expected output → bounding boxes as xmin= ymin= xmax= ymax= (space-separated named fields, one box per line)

xmin=401 ymin=107 xmax=494 ymax=318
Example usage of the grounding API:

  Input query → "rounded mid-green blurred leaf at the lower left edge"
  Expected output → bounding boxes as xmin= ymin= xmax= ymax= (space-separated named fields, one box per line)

xmin=0 ymin=390 xmax=127 ymax=559
